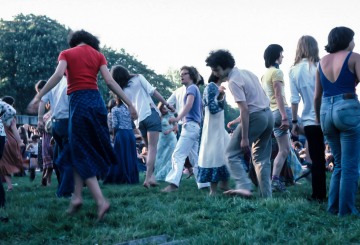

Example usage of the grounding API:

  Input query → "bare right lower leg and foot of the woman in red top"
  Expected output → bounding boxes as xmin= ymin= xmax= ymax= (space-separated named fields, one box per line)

xmin=85 ymin=176 xmax=110 ymax=221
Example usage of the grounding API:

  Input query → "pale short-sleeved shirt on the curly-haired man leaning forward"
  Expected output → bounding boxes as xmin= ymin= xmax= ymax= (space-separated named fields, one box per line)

xmin=228 ymin=67 xmax=269 ymax=114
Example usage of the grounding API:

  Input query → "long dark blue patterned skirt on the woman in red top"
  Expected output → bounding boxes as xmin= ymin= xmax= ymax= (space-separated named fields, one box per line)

xmin=69 ymin=90 xmax=116 ymax=180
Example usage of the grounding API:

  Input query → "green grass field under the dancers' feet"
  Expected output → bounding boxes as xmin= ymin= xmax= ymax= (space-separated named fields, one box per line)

xmin=0 ymin=173 xmax=360 ymax=245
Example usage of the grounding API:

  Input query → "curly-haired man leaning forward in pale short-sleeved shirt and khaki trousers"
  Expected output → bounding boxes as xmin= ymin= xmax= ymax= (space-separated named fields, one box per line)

xmin=206 ymin=50 xmax=274 ymax=198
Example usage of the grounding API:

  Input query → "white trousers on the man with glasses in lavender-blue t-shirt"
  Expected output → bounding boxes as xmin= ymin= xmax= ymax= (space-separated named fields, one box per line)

xmin=165 ymin=121 xmax=210 ymax=188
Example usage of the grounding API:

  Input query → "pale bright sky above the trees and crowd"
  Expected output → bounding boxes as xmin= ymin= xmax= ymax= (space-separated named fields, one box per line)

xmin=0 ymin=0 xmax=360 ymax=105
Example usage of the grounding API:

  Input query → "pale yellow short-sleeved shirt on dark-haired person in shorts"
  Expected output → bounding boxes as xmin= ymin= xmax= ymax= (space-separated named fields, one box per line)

xmin=261 ymin=67 xmax=288 ymax=111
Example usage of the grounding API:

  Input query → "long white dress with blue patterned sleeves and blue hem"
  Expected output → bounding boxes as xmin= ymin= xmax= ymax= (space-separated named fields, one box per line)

xmin=198 ymin=82 xmax=230 ymax=183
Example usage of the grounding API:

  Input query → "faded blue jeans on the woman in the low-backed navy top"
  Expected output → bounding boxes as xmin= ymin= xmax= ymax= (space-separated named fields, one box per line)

xmin=320 ymin=94 xmax=360 ymax=216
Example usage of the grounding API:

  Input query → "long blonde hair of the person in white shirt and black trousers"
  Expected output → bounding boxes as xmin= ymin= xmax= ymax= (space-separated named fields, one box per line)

xmin=294 ymin=36 xmax=320 ymax=65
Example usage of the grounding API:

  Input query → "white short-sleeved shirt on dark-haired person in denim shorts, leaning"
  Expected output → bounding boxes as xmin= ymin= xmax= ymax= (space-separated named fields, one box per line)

xmin=124 ymin=74 xmax=160 ymax=128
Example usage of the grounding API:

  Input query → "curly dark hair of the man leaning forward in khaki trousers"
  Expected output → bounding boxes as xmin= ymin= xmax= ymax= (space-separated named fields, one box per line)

xmin=205 ymin=49 xmax=235 ymax=70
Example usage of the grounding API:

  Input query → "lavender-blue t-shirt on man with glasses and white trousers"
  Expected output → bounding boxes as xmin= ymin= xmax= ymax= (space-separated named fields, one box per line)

xmin=184 ymin=84 xmax=201 ymax=124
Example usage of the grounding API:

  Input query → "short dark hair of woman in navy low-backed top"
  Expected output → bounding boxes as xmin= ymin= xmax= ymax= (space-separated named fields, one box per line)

xmin=325 ymin=26 xmax=355 ymax=54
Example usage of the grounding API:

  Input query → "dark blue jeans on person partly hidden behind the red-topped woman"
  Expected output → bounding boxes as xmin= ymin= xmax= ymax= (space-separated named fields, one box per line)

xmin=52 ymin=119 xmax=74 ymax=197
